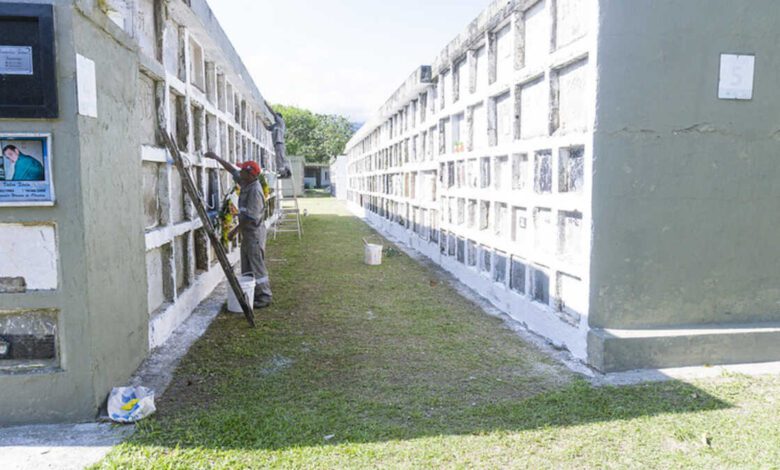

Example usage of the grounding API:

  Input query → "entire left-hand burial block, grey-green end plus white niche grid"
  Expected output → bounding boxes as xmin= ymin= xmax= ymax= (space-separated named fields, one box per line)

xmin=0 ymin=0 xmax=278 ymax=425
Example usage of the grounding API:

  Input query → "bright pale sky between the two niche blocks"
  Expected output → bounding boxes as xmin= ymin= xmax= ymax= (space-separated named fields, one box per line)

xmin=209 ymin=0 xmax=490 ymax=122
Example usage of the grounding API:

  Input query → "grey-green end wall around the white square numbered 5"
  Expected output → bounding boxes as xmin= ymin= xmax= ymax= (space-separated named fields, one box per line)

xmin=589 ymin=0 xmax=780 ymax=328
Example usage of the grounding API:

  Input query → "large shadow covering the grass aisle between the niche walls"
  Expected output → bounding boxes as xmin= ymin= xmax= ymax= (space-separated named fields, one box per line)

xmin=125 ymin=211 xmax=731 ymax=452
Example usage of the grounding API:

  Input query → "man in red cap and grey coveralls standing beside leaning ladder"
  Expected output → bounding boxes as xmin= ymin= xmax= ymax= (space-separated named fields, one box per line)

xmin=205 ymin=152 xmax=271 ymax=308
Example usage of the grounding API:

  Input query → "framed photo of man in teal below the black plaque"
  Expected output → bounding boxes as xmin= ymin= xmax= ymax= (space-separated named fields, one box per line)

xmin=0 ymin=133 xmax=54 ymax=206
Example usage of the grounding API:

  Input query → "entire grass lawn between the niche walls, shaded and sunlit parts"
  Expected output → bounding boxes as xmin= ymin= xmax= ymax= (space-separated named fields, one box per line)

xmin=98 ymin=199 xmax=780 ymax=468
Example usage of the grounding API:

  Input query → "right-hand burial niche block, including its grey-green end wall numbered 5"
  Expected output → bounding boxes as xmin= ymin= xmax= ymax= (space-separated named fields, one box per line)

xmin=343 ymin=0 xmax=780 ymax=372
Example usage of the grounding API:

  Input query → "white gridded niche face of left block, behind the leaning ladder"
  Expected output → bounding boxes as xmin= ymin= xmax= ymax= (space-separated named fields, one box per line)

xmin=119 ymin=0 xmax=275 ymax=348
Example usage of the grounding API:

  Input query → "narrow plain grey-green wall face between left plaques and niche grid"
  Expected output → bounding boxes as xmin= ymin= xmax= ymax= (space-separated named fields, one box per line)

xmin=74 ymin=3 xmax=149 ymax=414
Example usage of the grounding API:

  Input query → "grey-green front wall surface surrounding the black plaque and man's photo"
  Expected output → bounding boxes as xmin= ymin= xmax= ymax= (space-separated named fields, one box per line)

xmin=0 ymin=1 xmax=94 ymax=424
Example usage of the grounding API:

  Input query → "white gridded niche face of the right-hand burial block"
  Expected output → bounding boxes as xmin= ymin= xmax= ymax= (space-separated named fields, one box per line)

xmin=347 ymin=0 xmax=595 ymax=358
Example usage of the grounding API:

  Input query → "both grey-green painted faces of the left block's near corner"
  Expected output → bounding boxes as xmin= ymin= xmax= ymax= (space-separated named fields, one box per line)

xmin=0 ymin=0 xmax=148 ymax=425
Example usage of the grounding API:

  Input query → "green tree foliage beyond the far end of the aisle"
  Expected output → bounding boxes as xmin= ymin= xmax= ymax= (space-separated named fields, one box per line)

xmin=273 ymin=105 xmax=353 ymax=163
